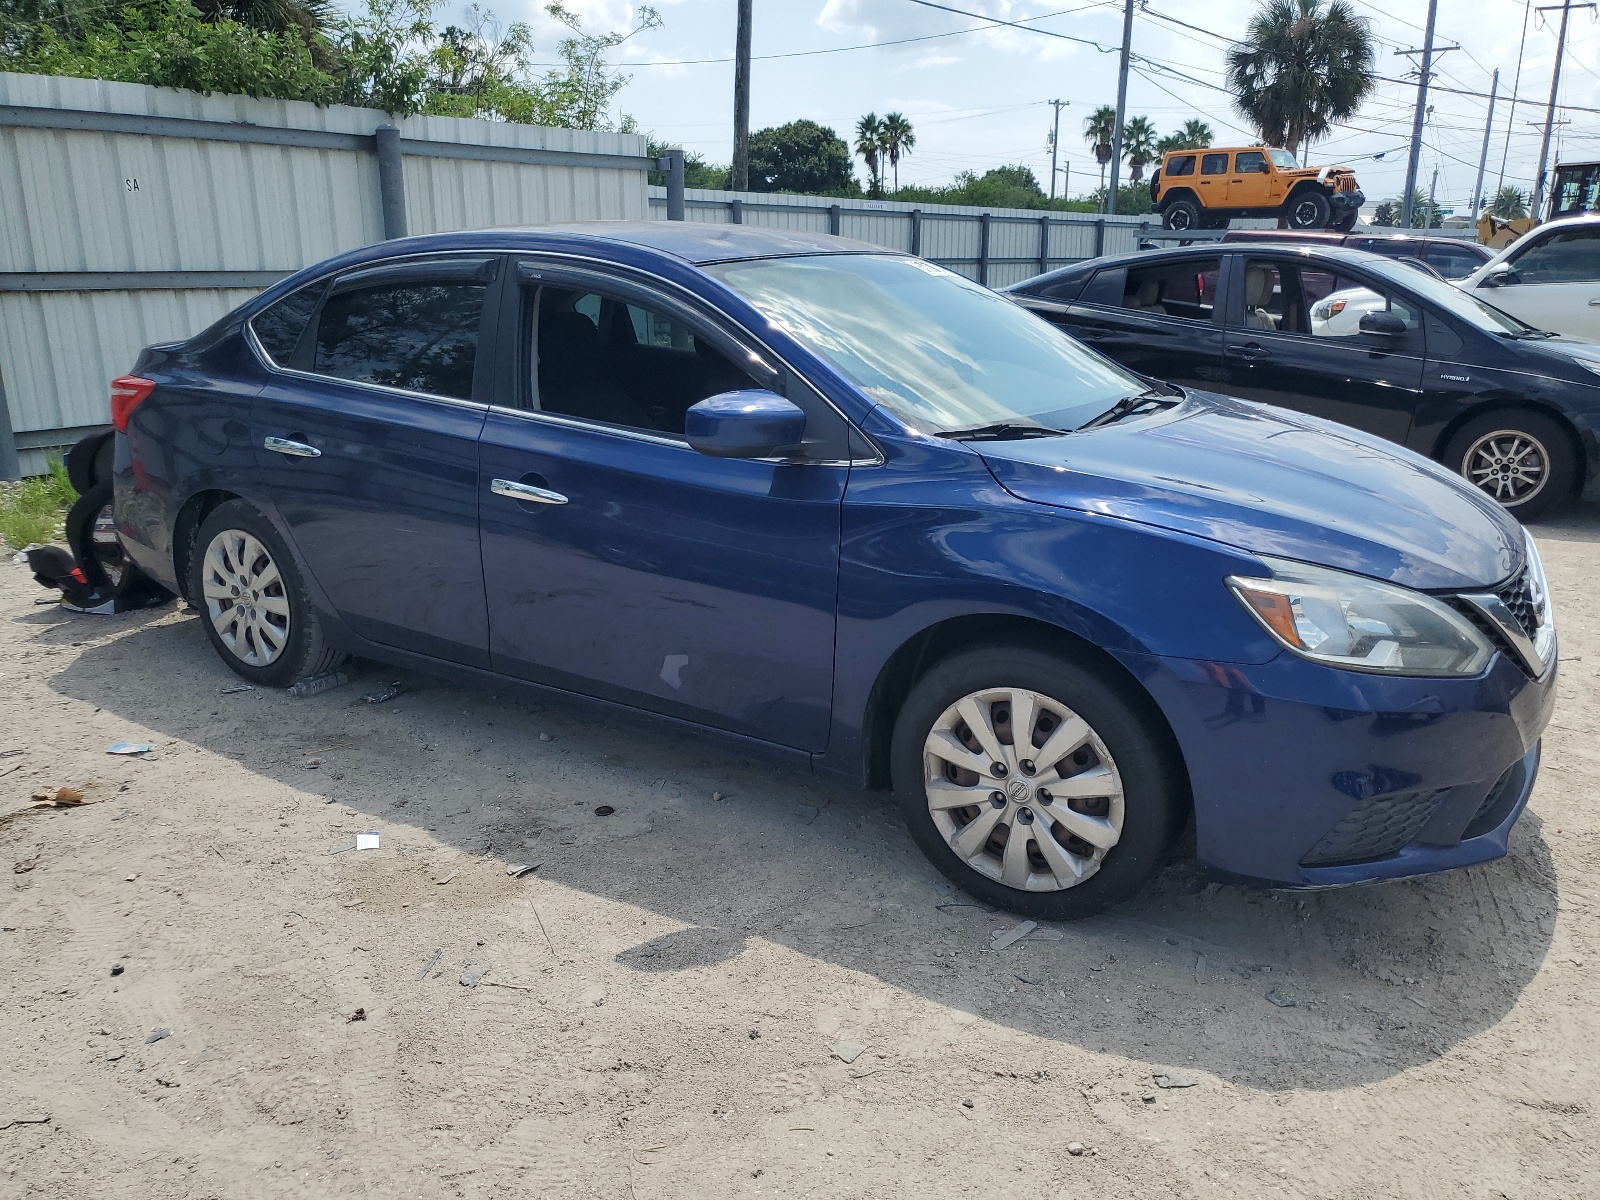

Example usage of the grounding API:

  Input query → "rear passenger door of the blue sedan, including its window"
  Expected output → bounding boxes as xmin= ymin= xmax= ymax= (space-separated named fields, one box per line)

xmin=251 ymin=256 xmax=499 ymax=667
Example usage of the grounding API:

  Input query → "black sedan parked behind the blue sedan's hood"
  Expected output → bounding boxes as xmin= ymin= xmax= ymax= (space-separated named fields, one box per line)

xmin=1006 ymin=245 xmax=1600 ymax=520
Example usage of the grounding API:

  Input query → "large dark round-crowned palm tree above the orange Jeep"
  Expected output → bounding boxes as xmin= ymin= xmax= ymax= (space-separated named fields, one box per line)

xmin=1227 ymin=0 xmax=1373 ymax=154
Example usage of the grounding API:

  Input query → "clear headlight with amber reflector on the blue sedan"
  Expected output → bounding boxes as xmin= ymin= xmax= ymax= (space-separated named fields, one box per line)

xmin=1227 ymin=557 xmax=1494 ymax=675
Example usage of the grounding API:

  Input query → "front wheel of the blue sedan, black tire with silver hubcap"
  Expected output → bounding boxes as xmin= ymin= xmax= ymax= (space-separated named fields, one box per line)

xmin=890 ymin=645 xmax=1189 ymax=920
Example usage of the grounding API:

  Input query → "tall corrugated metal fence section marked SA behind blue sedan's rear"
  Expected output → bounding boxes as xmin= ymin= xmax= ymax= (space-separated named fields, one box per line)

xmin=0 ymin=72 xmax=654 ymax=478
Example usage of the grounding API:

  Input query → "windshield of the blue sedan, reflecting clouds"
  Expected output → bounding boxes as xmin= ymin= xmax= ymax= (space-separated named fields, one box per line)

xmin=706 ymin=254 xmax=1147 ymax=434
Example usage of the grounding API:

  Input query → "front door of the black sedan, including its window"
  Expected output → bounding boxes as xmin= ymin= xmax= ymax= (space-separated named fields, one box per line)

xmin=1226 ymin=256 xmax=1422 ymax=442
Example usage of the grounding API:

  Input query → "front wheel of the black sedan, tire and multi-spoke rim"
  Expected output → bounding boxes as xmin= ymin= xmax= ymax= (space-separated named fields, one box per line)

xmin=1445 ymin=408 xmax=1578 ymax=522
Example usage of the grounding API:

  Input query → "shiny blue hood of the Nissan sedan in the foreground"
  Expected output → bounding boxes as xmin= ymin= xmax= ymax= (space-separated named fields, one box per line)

xmin=973 ymin=392 xmax=1523 ymax=590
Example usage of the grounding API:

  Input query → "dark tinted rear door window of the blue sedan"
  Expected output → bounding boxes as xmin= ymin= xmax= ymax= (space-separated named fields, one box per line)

xmin=312 ymin=282 xmax=488 ymax=400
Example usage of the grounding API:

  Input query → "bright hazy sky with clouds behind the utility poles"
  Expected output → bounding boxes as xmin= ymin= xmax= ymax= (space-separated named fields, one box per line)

xmin=499 ymin=0 xmax=1600 ymax=211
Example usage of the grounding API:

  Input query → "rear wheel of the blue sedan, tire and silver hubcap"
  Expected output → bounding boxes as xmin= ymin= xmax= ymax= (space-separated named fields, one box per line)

xmin=189 ymin=501 xmax=344 ymax=688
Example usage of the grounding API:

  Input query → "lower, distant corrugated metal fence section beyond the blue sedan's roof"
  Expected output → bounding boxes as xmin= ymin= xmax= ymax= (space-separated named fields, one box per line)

xmin=650 ymin=187 xmax=1221 ymax=288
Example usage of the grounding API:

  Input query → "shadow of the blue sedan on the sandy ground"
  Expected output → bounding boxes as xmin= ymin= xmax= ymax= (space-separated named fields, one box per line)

xmin=34 ymin=582 xmax=1557 ymax=1090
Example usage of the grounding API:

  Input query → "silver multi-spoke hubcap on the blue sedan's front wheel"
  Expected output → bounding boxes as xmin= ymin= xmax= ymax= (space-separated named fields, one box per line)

xmin=923 ymin=688 xmax=1123 ymax=891
